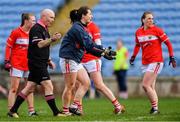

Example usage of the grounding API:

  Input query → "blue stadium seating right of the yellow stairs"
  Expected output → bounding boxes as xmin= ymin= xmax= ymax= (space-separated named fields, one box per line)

xmin=93 ymin=0 xmax=180 ymax=76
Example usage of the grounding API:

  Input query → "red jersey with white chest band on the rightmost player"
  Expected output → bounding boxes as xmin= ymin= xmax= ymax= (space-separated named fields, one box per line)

xmin=135 ymin=26 xmax=168 ymax=65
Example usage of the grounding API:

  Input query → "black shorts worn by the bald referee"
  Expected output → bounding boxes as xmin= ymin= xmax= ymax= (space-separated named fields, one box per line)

xmin=28 ymin=67 xmax=50 ymax=85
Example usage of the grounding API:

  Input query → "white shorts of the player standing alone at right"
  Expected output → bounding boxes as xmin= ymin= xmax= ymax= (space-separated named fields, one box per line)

xmin=141 ymin=62 xmax=164 ymax=74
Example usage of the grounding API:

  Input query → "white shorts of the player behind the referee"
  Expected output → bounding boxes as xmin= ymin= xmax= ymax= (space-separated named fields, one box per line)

xmin=10 ymin=68 xmax=29 ymax=78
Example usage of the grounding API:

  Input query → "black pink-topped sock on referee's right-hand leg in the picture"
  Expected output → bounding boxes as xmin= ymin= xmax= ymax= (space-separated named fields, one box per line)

xmin=45 ymin=94 xmax=59 ymax=115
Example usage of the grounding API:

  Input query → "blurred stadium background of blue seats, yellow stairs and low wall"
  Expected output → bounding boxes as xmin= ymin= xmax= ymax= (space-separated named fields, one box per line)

xmin=0 ymin=0 xmax=180 ymax=96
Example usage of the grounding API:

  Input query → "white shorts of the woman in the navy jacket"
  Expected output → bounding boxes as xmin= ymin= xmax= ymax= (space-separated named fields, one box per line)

xmin=59 ymin=58 xmax=84 ymax=73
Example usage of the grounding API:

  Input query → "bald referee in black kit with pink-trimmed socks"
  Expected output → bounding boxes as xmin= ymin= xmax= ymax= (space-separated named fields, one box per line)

xmin=8 ymin=9 xmax=61 ymax=118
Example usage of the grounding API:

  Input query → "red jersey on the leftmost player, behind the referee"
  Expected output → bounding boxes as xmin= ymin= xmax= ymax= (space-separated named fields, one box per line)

xmin=5 ymin=27 xmax=29 ymax=71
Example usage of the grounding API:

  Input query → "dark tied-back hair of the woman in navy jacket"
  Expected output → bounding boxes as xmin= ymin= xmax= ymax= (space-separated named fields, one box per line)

xmin=69 ymin=6 xmax=91 ymax=23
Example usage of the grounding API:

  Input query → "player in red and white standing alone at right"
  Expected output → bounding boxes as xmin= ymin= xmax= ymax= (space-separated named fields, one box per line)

xmin=130 ymin=11 xmax=176 ymax=114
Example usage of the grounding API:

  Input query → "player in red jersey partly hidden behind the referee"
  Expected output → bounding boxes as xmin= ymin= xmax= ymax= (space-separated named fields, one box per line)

xmin=4 ymin=13 xmax=37 ymax=116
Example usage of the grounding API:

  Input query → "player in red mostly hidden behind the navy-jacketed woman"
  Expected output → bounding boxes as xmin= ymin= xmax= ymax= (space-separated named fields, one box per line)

xmin=71 ymin=21 xmax=125 ymax=114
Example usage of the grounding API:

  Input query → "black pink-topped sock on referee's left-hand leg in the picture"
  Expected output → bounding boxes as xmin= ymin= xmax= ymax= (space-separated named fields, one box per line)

xmin=10 ymin=92 xmax=27 ymax=113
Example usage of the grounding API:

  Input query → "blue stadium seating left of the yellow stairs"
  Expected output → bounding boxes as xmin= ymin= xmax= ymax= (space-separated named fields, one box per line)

xmin=0 ymin=0 xmax=65 ymax=64
